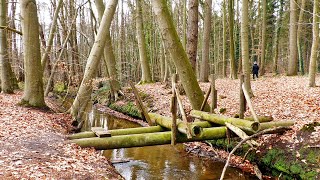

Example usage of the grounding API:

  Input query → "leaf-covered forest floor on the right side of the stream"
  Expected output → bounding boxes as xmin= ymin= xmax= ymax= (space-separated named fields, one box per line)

xmin=127 ymin=75 xmax=320 ymax=179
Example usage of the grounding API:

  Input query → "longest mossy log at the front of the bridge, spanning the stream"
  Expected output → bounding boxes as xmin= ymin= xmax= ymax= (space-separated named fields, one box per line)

xmin=68 ymin=127 xmax=227 ymax=150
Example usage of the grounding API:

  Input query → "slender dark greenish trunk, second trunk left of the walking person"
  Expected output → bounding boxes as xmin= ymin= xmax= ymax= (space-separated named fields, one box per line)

xmin=228 ymin=0 xmax=237 ymax=79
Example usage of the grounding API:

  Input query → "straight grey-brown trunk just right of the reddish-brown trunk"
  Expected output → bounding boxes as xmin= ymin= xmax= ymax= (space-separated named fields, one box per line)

xmin=200 ymin=0 xmax=212 ymax=82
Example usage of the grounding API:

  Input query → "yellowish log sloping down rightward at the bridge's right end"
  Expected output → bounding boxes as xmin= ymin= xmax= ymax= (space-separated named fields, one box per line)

xmin=190 ymin=110 xmax=260 ymax=132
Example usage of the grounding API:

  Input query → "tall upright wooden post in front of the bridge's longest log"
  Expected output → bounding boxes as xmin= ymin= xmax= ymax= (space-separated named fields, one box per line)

xmin=171 ymin=74 xmax=177 ymax=145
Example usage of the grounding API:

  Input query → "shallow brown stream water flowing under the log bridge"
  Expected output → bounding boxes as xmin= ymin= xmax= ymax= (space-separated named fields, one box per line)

xmin=84 ymin=106 xmax=252 ymax=180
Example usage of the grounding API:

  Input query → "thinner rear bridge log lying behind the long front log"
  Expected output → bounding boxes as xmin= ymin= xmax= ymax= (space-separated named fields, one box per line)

xmin=67 ymin=126 xmax=165 ymax=139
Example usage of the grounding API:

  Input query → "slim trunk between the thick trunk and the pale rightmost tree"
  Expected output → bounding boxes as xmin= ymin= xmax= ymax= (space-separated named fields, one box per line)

xmin=297 ymin=0 xmax=306 ymax=74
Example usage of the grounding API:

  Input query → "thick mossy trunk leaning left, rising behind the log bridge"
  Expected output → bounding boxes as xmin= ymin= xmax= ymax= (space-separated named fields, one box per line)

xmin=151 ymin=0 xmax=209 ymax=110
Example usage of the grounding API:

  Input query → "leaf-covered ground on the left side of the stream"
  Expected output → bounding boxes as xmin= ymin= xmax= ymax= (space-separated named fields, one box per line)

xmin=0 ymin=91 xmax=122 ymax=180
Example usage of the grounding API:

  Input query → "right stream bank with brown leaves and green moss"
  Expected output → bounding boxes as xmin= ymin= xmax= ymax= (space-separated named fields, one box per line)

xmin=91 ymin=77 xmax=320 ymax=179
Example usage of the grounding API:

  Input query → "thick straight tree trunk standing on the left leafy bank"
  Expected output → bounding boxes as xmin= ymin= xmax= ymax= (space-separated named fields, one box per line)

xmin=19 ymin=0 xmax=46 ymax=107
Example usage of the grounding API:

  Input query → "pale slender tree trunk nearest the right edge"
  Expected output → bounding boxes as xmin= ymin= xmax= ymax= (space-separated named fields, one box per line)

xmin=309 ymin=0 xmax=320 ymax=87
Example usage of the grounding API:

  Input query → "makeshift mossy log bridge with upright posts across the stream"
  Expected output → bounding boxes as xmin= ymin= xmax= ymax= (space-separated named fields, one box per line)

xmin=68 ymin=75 xmax=294 ymax=150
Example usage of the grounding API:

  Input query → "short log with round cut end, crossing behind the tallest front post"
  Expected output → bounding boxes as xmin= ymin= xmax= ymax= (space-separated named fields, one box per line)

xmin=148 ymin=113 xmax=211 ymax=136
